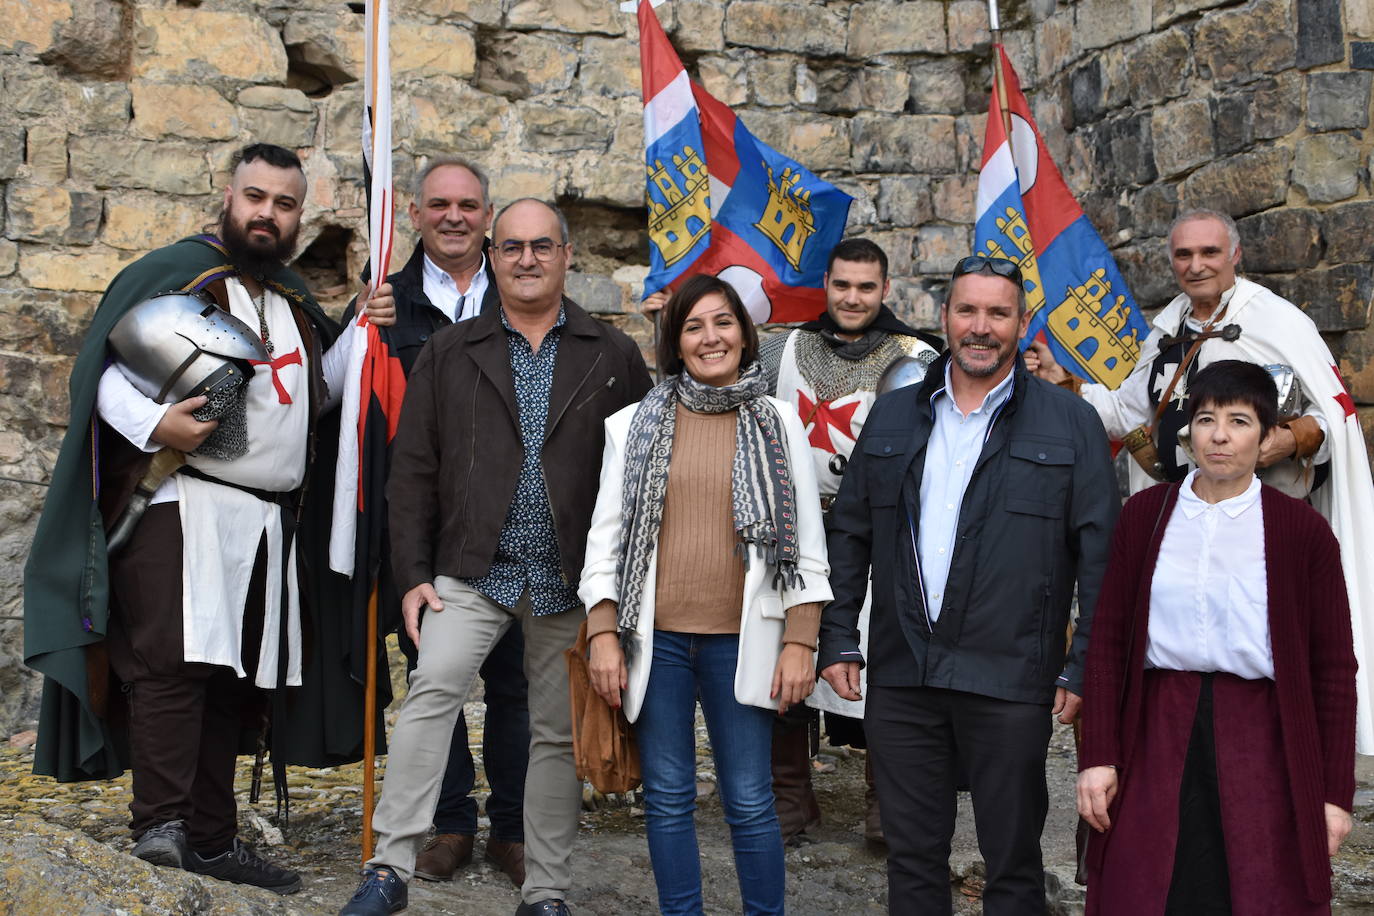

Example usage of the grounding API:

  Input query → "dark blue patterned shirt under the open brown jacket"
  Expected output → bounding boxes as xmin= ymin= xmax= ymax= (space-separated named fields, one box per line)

xmin=466 ymin=306 xmax=581 ymax=617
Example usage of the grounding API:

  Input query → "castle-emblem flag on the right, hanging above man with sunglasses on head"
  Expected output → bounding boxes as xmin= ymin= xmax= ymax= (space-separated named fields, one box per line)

xmin=974 ymin=45 xmax=1150 ymax=389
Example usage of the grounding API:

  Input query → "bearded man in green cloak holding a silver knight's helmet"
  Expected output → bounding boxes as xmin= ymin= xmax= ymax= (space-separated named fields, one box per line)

xmin=25 ymin=144 xmax=390 ymax=894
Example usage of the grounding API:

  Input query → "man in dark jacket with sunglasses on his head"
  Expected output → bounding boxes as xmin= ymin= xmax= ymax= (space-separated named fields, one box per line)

xmin=818 ymin=257 xmax=1118 ymax=913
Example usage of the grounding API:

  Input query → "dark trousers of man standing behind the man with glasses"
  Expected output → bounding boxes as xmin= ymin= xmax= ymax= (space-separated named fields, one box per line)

xmin=400 ymin=626 xmax=529 ymax=843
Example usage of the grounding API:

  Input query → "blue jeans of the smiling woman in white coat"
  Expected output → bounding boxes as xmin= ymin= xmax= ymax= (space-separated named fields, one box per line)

xmin=635 ymin=630 xmax=783 ymax=916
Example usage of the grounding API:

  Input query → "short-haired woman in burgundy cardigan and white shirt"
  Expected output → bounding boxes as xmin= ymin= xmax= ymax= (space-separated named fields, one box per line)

xmin=1079 ymin=361 xmax=1356 ymax=916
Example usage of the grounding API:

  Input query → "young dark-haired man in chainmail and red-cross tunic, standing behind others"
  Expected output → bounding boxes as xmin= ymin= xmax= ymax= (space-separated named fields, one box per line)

xmin=758 ymin=238 xmax=944 ymax=843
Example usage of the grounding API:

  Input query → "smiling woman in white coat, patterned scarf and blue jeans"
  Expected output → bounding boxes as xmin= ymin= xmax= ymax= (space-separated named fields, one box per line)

xmin=577 ymin=274 xmax=830 ymax=913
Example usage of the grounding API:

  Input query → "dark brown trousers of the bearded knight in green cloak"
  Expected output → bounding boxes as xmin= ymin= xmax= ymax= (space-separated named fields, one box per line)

xmin=107 ymin=503 xmax=267 ymax=853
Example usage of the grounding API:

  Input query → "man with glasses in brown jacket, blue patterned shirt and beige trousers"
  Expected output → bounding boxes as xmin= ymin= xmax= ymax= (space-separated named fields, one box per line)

xmin=341 ymin=198 xmax=651 ymax=916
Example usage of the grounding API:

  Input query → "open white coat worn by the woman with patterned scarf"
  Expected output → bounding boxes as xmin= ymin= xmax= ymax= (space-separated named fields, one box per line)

xmin=577 ymin=398 xmax=831 ymax=722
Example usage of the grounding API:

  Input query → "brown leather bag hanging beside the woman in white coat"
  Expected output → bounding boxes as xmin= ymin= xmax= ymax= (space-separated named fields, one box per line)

xmin=563 ymin=621 xmax=640 ymax=795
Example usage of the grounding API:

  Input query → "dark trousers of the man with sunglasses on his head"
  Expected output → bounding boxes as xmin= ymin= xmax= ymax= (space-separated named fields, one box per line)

xmin=864 ymin=684 xmax=1050 ymax=916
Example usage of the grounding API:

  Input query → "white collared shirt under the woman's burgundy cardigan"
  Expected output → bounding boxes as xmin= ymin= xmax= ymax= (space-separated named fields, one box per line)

xmin=1145 ymin=471 xmax=1274 ymax=680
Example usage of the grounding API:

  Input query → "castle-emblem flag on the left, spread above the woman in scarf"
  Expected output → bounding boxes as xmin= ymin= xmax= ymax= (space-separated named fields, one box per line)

xmin=638 ymin=0 xmax=852 ymax=321
